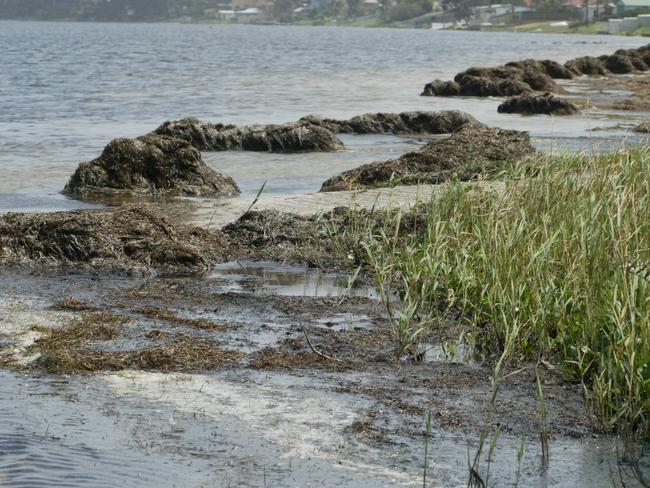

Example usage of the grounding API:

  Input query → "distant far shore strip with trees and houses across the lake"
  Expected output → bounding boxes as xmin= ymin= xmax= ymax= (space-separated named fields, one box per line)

xmin=0 ymin=0 xmax=650 ymax=36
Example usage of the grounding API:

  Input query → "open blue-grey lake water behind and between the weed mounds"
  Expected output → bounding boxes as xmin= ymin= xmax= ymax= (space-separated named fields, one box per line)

xmin=0 ymin=22 xmax=644 ymax=212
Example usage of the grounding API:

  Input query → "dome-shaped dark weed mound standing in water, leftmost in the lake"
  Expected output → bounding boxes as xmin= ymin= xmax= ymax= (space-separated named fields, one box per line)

xmin=63 ymin=135 xmax=239 ymax=199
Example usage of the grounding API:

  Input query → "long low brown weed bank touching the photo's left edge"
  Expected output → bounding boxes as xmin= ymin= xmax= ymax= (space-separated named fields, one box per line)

xmin=0 ymin=205 xmax=221 ymax=269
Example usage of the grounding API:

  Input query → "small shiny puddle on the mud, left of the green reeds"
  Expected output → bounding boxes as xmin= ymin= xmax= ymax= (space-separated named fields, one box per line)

xmin=210 ymin=261 xmax=379 ymax=299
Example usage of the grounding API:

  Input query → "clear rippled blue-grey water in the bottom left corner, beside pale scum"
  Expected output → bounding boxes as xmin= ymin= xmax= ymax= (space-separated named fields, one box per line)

xmin=0 ymin=372 xmax=218 ymax=488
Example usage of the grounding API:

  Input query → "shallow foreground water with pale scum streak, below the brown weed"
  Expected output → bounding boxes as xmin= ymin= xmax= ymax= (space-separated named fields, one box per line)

xmin=0 ymin=371 xmax=638 ymax=488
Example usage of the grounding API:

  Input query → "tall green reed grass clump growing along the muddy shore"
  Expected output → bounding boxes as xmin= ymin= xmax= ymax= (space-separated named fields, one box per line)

xmin=345 ymin=149 xmax=650 ymax=437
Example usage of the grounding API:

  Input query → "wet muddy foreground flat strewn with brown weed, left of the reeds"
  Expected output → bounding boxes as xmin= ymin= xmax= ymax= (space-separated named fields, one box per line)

xmin=0 ymin=263 xmax=644 ymax=487
